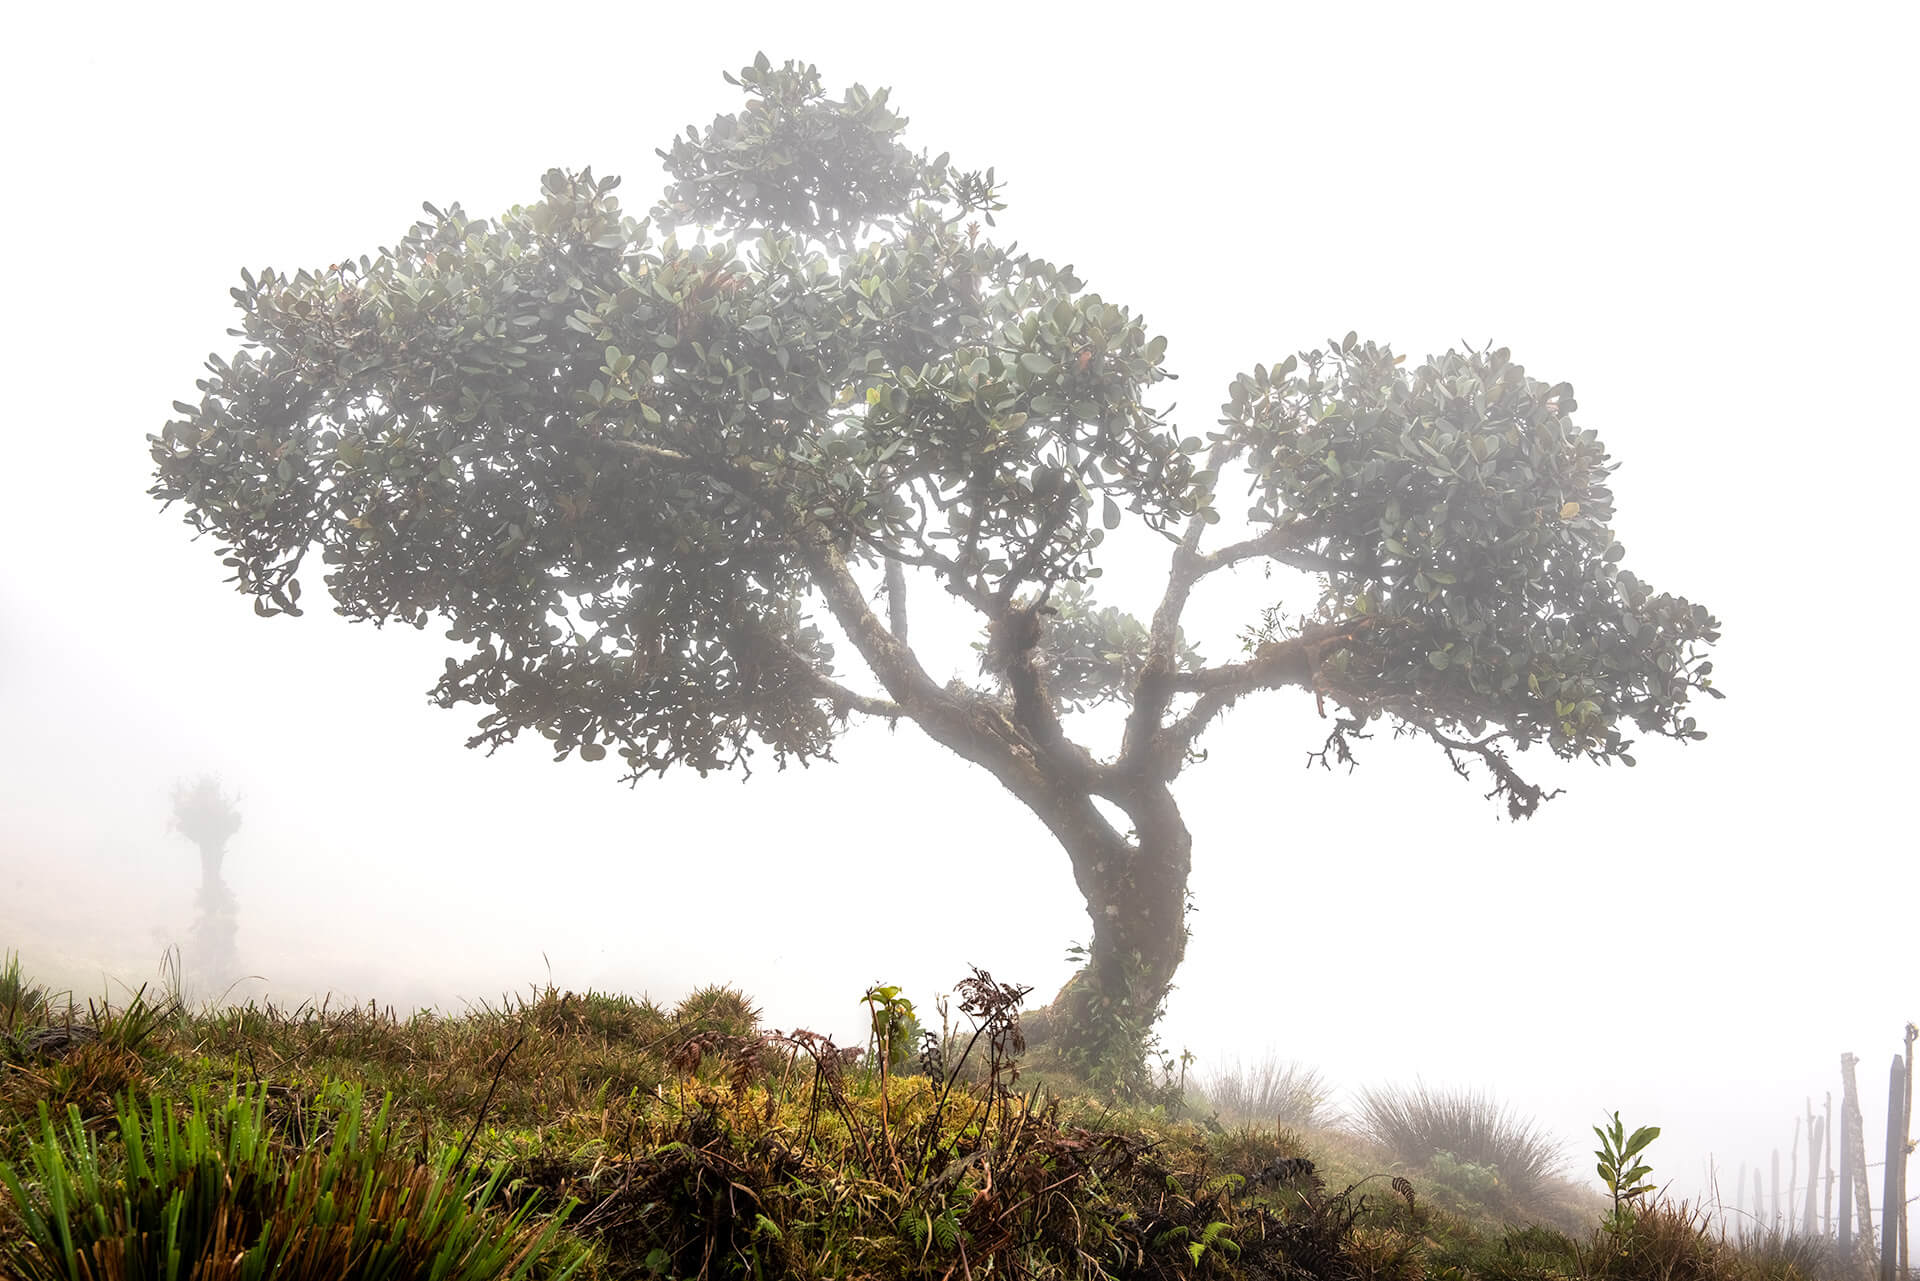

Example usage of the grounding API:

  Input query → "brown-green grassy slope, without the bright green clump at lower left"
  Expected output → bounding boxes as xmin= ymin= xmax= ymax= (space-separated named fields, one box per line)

xmin=0 ymin=960 xmax=1866 ymax=1281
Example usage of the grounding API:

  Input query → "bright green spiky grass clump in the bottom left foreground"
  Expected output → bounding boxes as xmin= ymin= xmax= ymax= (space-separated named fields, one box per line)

xmin=0 ymin=1087 xmax=584 ymax=1281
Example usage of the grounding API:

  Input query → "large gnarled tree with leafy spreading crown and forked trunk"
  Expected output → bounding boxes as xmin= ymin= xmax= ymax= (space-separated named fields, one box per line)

xmin=152 ymin=56 xmax=1716 ymax=1052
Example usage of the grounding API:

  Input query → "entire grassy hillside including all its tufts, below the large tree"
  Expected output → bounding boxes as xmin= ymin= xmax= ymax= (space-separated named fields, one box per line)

xmin=0 ymin=966 xmax=1857 ymax=1281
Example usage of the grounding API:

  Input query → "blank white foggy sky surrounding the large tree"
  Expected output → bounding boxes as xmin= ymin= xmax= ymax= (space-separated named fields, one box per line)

xmin=0 ymin=4 xmax=1920 ymax=1208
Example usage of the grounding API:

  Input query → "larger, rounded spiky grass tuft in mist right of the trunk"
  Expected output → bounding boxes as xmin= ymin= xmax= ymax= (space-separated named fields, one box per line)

xmin=1354 ymin=1085 xmax=1567 ymax=1202
